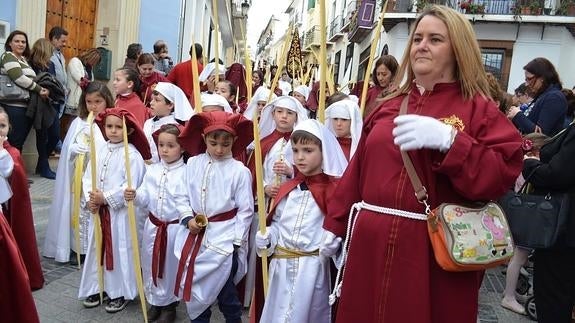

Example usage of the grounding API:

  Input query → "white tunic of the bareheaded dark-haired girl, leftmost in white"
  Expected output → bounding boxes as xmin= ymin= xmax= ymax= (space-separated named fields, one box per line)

xmin=42 ymin=117 xmax=106 ymax=262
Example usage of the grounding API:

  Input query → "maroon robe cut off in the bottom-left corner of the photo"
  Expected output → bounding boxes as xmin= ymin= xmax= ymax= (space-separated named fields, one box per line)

xmin=0 ymin=212 xmax=40 ymax=323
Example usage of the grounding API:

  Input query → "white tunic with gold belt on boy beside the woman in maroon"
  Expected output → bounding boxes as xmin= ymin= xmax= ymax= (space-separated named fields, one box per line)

xmin=260 ymin=186 xmax=331 ymax=323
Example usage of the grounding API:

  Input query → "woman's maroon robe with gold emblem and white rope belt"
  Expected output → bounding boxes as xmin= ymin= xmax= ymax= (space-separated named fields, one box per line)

xmin=324 ymin=83 xmax=523 ymax=323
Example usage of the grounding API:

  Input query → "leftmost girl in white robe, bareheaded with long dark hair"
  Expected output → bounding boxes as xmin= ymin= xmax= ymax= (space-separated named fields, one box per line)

xmin=42 ymin=82 xmax=114 ymax=262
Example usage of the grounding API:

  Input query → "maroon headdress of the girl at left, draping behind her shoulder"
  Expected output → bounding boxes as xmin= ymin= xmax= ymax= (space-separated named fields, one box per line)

xmin=95 ymin=108 xmax=152 ymax=160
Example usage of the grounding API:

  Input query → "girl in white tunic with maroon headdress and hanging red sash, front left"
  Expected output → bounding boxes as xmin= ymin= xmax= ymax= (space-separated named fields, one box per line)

xmin=78 ymin=108 xmax=151 ymax=313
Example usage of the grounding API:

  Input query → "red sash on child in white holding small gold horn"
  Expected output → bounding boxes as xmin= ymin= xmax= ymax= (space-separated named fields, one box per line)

xmin=174 ymin=208 xmax=238 ymax=302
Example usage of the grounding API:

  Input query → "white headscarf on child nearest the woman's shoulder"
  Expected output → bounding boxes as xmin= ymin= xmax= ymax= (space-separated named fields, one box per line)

xmin=325 ymin=99 xmax=363 ymax=158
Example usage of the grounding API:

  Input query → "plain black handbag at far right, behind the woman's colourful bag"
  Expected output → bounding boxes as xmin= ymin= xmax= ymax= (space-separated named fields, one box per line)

xmin=499 ymin=168 xmax=569 ymax=249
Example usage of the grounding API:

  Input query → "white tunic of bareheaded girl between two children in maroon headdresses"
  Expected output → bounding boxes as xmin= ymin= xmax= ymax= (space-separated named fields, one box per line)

xmin=135 ymin=158 xmax=186 ymax=306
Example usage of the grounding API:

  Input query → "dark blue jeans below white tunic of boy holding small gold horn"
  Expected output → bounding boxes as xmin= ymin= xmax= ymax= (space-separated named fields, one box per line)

xmin=192 ymin=250 xmax=242 ymax=323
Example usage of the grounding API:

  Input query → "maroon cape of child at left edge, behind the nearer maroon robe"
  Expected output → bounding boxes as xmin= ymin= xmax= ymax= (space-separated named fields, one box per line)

xmin=4 ymin=141 xmax=44 ymax=290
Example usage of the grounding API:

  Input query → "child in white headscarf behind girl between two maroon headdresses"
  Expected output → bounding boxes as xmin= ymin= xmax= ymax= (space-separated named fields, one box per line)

xmin=142 ymin=82 xmax=194 ymax=164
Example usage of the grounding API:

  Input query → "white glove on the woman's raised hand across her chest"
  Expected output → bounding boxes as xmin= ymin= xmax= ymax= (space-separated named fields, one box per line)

xmin=393 ymin=114 xmax=454 ymax=152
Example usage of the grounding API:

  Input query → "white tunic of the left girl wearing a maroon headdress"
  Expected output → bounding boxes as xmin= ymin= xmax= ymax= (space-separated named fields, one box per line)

xmin=78 ymin=142 xmax=146 ymax=299
